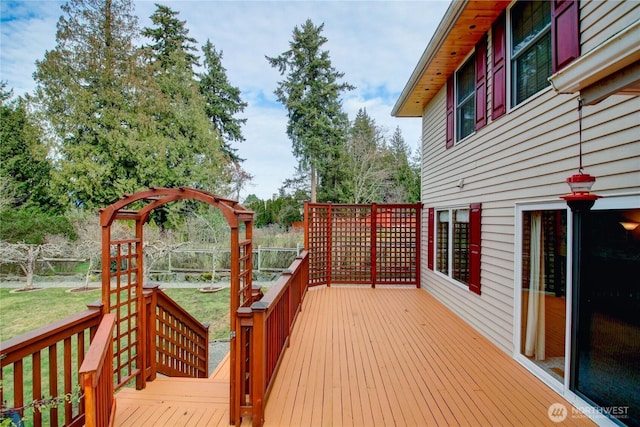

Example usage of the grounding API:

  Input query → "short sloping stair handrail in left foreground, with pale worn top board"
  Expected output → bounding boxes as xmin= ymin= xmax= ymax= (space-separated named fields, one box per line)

xmin=79 ymin=313 xmax=116 ymax=427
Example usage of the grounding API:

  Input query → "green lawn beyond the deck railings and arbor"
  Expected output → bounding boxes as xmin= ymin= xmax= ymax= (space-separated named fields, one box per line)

xmin=0 ymin=288 xmax=229 ymax=341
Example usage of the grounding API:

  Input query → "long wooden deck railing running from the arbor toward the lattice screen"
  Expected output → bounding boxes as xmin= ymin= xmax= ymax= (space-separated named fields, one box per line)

xmin=232 ymin=251 xmax=309 ymax=426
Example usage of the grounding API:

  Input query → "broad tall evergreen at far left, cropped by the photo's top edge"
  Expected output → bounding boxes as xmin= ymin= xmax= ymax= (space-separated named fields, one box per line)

xmin=33 ymin=0 xmax=145 ymax=208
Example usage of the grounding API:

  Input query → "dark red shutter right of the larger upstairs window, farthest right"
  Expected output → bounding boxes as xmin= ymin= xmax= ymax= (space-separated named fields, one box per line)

xmin=551 ymin=0 xmax=580 ymax=73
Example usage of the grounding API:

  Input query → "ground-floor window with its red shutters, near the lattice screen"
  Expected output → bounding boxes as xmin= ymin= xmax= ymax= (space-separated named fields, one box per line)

xmin=427 ymin=203 xmax=481 ymax=294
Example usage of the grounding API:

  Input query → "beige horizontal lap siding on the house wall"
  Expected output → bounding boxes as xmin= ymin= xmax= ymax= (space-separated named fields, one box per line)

xmin=421 ymin=2 xmax=640 ymax=353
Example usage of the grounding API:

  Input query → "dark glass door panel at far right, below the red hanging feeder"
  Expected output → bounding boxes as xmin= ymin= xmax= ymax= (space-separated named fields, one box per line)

xmin=571 ymin=209 xmax=640 ymax=425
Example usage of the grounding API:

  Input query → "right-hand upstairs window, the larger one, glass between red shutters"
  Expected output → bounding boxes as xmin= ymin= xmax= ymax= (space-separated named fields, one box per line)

xmin=510 ymin=1 xmax=551 ymax=106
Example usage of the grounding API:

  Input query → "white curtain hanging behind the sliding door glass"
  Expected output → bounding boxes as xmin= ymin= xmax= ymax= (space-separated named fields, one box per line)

xmin=524 ymin=212 xmax=545 ymax=360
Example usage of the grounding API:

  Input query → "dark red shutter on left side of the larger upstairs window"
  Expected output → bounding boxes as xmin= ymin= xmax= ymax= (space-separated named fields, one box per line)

xmin=491 ymin=12 xmax=507 ymax=120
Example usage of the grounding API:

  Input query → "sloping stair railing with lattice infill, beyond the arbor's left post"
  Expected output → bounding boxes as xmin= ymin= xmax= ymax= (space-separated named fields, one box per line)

xmin=144 ymin=285 xmax=209 ymax=381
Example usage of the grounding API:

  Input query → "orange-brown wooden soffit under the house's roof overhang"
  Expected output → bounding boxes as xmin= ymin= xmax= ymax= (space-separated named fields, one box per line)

xmin=391 ymin=0 xmax=511 ymax=117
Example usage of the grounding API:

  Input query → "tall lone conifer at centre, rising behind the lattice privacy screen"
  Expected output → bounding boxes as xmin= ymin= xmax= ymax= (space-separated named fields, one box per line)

xmin=266 ymin=20 xmax=354 ymax=202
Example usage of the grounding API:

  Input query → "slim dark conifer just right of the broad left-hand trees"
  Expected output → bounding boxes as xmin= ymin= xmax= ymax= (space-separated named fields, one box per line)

xmin=198 ymin=40 xmax=247 ymax=162
